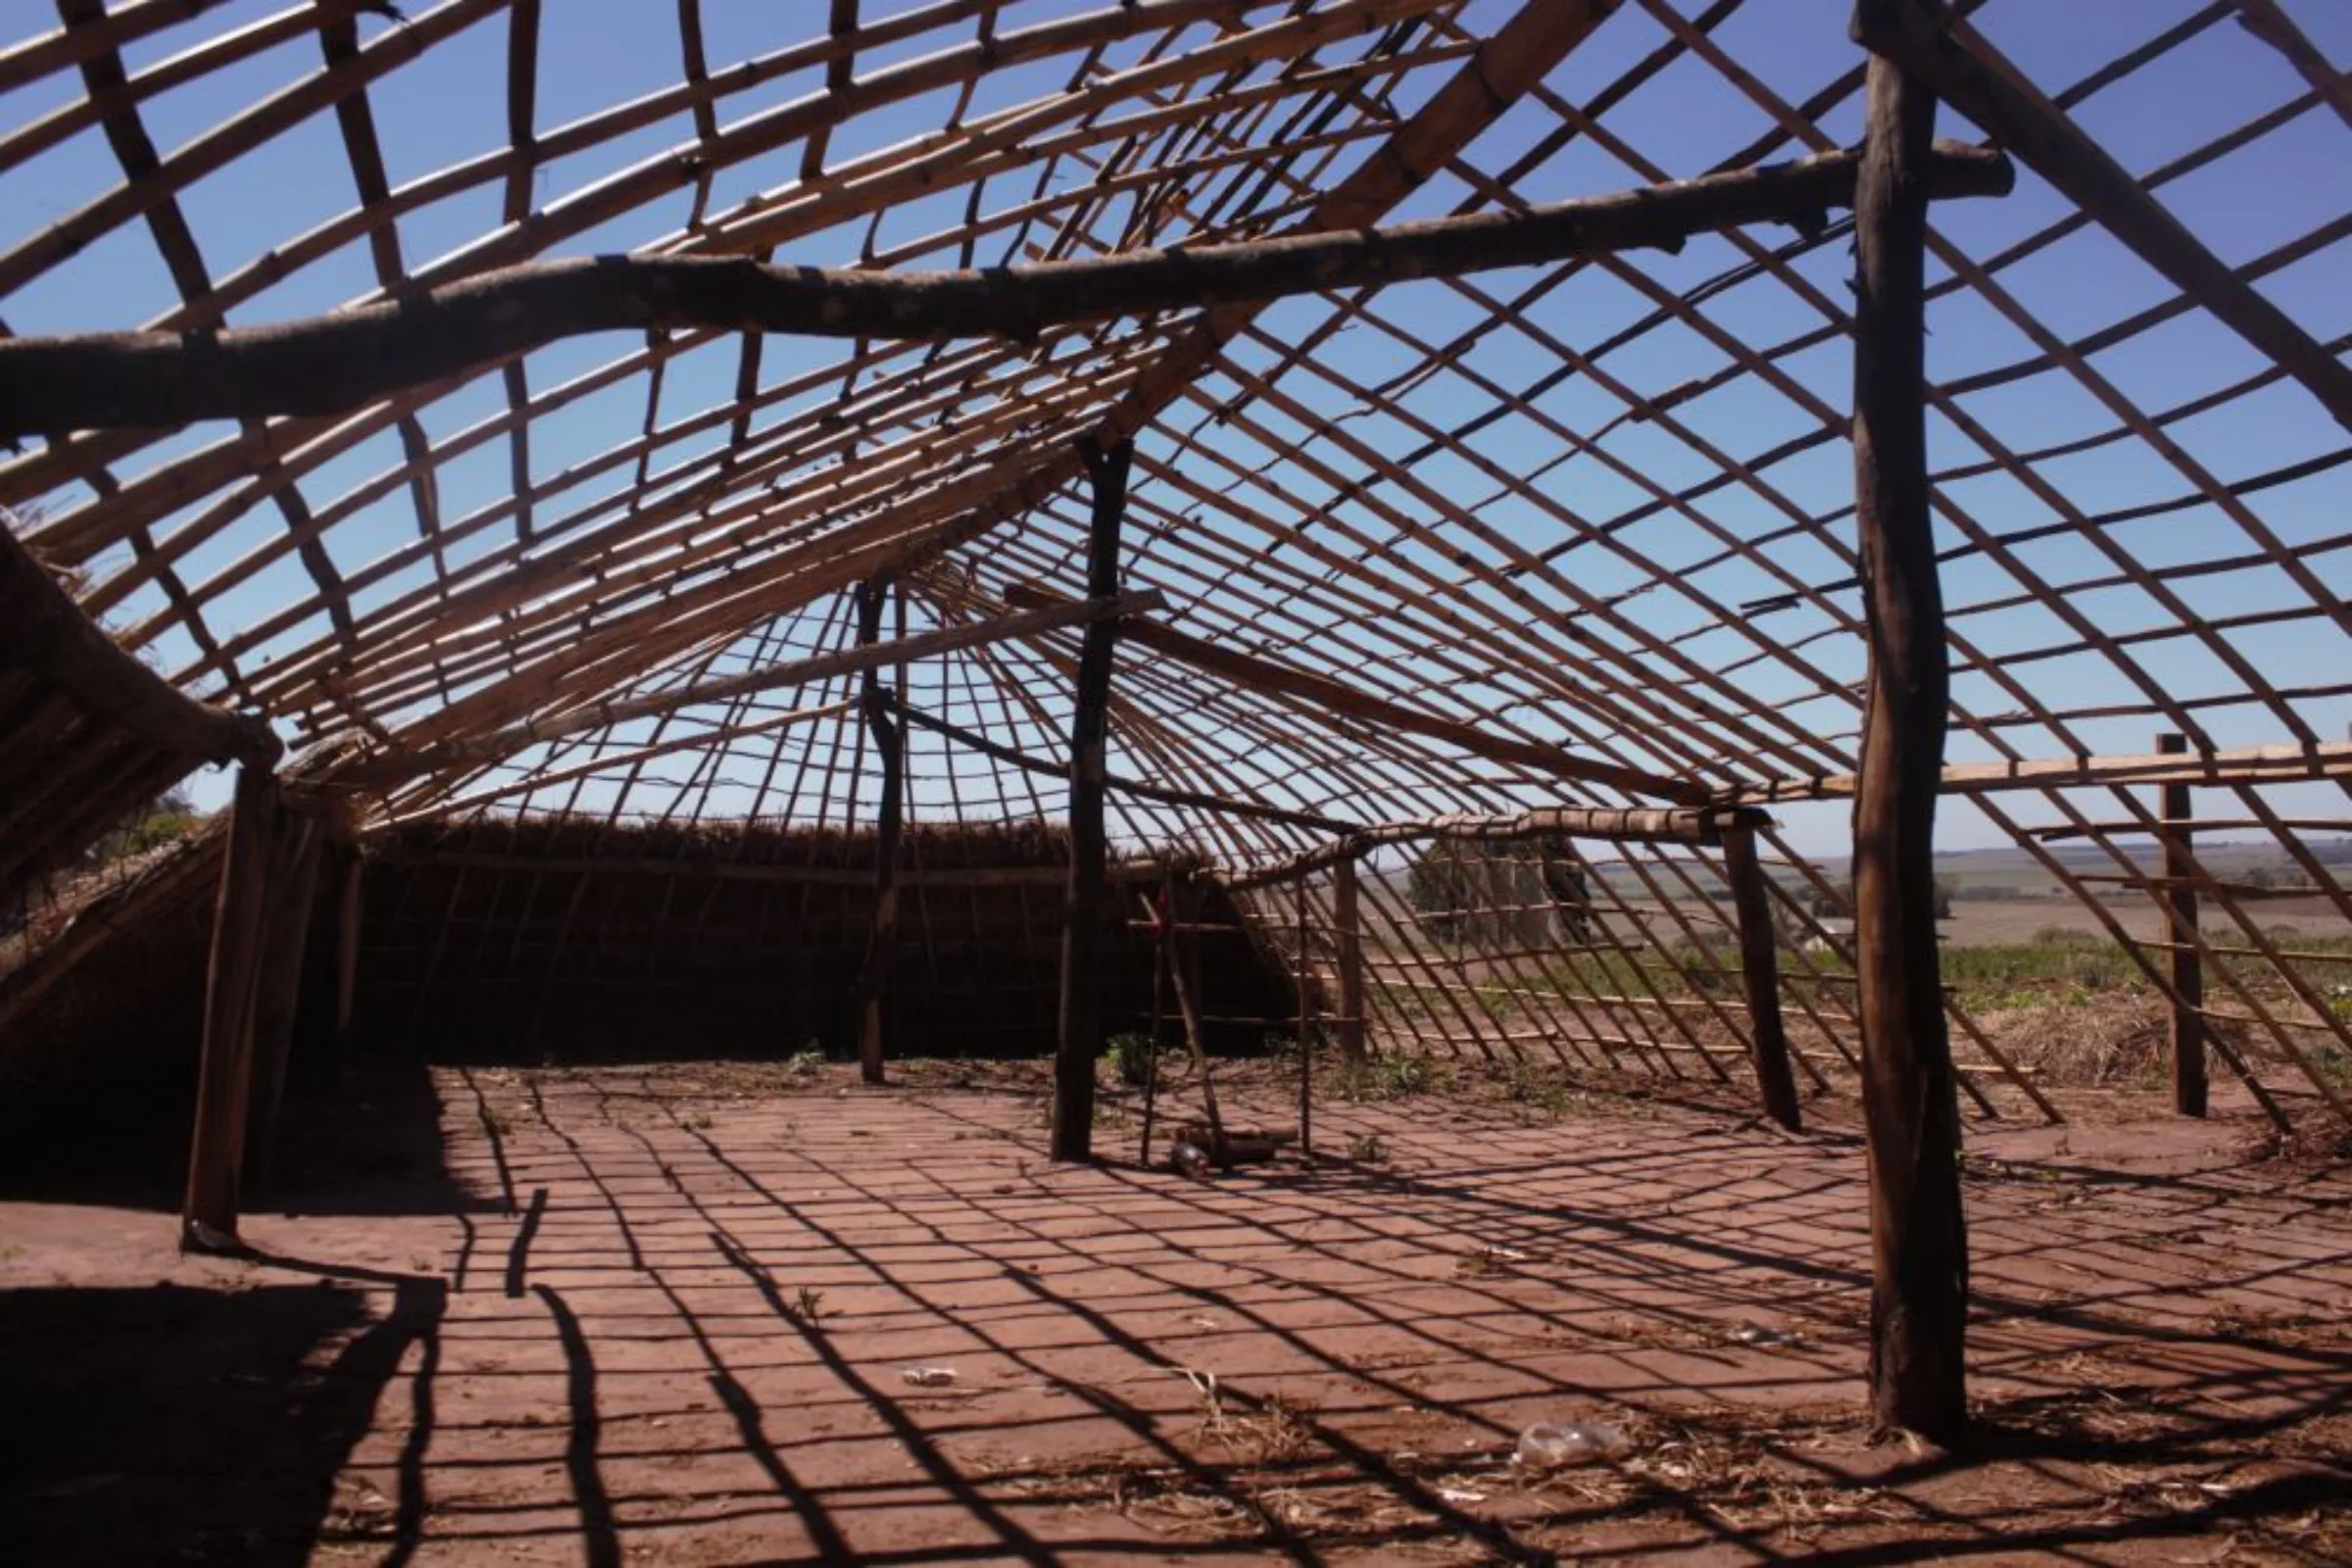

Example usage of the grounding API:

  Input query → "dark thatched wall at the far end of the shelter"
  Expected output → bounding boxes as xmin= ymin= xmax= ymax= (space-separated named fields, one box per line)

xmin=360 ymin=820 xmax=1296 ymax=1060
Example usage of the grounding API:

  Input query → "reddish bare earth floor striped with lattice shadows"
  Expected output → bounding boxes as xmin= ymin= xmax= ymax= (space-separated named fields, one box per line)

xmin=0 ymin=1065 xmax=2352 ymax=1566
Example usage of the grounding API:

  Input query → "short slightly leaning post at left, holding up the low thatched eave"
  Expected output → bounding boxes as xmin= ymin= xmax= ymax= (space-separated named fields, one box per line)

xmin=178 ymin=764 xmax=282 ymax=1253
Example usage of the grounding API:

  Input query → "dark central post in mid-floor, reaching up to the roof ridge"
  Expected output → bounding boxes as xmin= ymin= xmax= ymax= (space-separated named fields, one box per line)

xmin=1054 ymin=442 xmax=1134 ymax=1159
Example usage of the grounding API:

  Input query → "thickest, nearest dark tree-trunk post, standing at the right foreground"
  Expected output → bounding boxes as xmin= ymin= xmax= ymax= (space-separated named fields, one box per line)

xmin=1853 ymin=0 xmax=1969 ymax=1444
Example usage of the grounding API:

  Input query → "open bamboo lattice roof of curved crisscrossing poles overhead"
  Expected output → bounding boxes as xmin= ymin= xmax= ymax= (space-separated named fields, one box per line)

xmin=0 ymin=0 xmax=2347 ymax=858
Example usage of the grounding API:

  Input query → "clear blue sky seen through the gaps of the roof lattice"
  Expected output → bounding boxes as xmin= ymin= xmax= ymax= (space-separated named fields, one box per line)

xmin=0 ymin=0 xmax=2352 ymax=851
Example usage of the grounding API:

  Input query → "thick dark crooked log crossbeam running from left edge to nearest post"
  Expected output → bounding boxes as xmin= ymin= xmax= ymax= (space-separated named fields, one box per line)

xmin=0 ymin=146 xmax=2013 ymax=437
